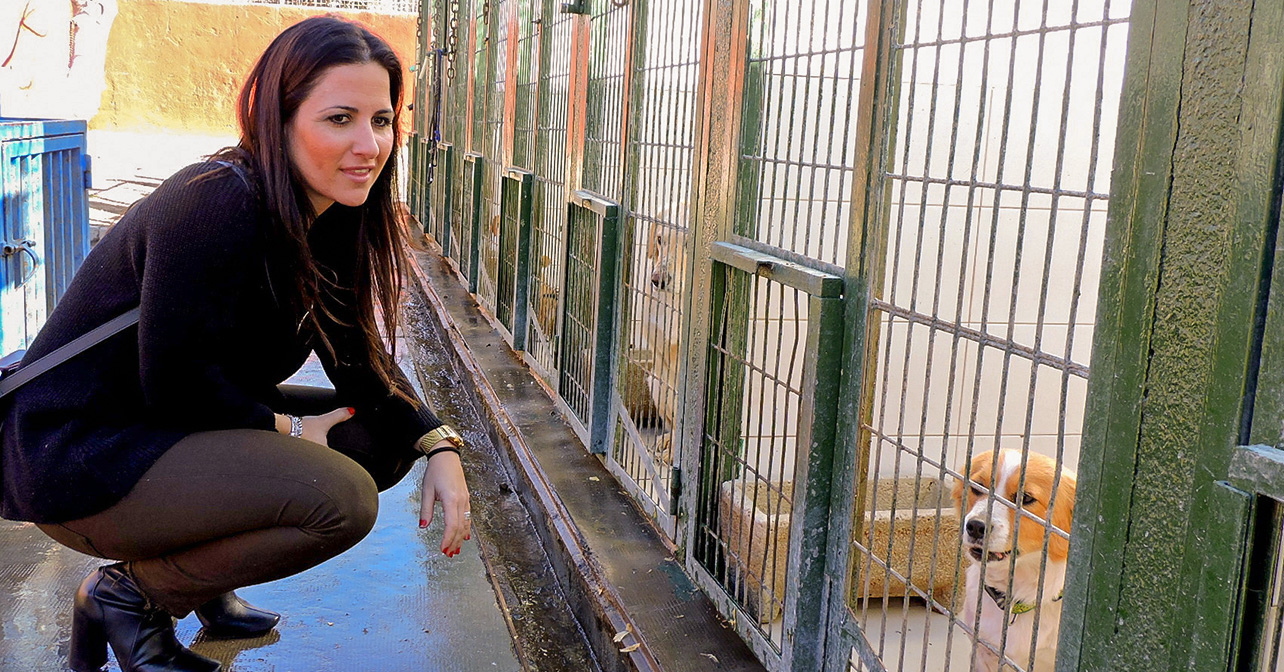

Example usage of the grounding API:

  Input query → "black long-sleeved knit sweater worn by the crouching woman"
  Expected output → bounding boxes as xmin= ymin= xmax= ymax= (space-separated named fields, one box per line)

xmin=0 ymin=163 xmax=440 ymax=523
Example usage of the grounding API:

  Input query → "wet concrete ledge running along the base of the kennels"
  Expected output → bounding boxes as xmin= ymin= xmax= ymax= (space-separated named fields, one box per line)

xmin=411 ymin=247 xmax=763 ymax=672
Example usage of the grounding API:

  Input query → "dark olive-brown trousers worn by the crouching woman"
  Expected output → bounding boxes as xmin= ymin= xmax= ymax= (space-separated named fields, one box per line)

xmin=40 ymin=385 xmax=413 ymax=618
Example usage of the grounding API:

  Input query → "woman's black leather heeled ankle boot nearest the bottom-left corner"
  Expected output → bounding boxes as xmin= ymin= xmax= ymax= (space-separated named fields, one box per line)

xmin=68 ymin=564 xmax=222 ymax=672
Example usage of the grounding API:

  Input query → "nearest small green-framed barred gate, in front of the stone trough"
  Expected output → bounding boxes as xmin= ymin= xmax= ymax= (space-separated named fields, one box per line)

xmin=693 ymin=243 xmax=844 ymax=669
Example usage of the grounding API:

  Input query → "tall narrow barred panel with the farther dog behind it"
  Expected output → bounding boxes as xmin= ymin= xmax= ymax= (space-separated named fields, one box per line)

xmin=611 ymin=0 xmax=704 ymax=535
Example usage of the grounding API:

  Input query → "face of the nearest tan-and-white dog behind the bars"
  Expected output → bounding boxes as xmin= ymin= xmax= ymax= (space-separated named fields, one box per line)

xmin=954 ymin=450 xmax=1075 ymax=563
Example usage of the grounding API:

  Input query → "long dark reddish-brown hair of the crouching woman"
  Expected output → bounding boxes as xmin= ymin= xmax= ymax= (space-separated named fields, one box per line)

xmin=234 ymin=15 xmax=416 ymax=402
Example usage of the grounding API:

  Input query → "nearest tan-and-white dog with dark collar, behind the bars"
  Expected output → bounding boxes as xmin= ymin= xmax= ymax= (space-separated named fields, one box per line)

xmin=954 ymin=450 xmax=1075 ymax=672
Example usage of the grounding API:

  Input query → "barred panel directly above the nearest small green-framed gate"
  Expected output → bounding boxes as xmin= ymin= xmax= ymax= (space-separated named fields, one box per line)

xmin=737 ymin=0 xmax=867 ymax=266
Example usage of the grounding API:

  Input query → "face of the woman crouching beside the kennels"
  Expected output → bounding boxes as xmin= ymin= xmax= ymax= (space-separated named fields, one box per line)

xmin=289 ymin=63 xmax=393 ymax=215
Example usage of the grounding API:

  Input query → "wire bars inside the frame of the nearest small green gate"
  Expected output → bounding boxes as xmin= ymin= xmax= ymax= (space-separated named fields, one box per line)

xmin=696 ymin=266 xmax=808 ymax=650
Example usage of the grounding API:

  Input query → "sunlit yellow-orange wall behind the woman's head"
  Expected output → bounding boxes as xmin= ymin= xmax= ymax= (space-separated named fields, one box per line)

xmin=90 ymin=0 xmax=416 ymax=135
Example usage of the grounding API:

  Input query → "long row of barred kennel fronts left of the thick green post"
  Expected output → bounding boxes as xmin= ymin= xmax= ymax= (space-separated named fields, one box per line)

xmin=412 ymin=0 xmax=1130 ymax=671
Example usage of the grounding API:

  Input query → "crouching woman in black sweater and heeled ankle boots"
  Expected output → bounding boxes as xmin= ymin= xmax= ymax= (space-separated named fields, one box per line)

xmin=0 ymin=17 xmax=470 ymax=672
